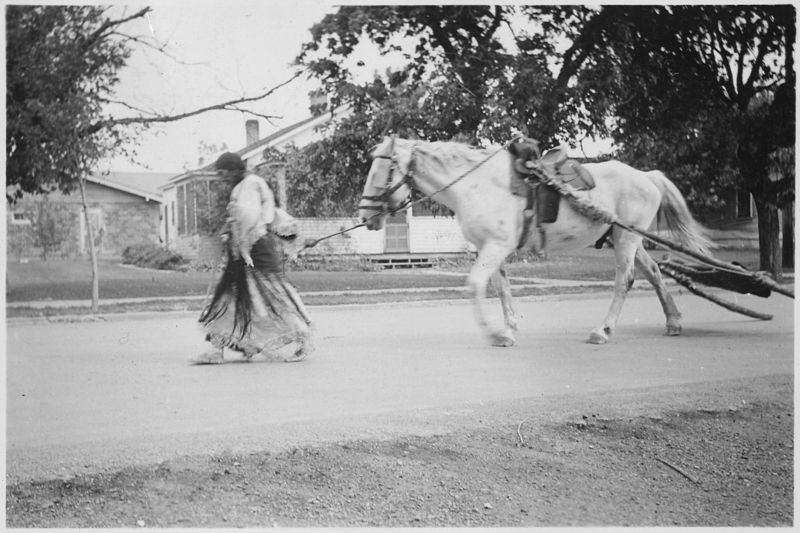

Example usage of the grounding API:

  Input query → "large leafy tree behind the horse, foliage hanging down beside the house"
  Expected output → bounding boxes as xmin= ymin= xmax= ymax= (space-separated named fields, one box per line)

xmin=287 ymin=6 xmax=624 ymax=216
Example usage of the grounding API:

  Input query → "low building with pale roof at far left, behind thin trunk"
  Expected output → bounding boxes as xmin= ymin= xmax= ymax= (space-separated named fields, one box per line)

xmin=7 ymin=172 xmax=172 ymax=260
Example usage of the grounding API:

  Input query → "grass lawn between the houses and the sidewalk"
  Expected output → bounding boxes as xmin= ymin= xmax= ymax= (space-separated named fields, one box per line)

xmin=6 ymin=248 xmax=772 ymax=302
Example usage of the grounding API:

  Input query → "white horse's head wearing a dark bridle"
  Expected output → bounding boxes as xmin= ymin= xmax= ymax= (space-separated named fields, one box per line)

xmin=358 ymin=135 xmax=412 ymax=230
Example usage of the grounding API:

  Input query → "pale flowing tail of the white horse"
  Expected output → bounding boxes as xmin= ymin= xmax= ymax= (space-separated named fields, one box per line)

xmin=647 ymin=170 xmax=716 ymax=255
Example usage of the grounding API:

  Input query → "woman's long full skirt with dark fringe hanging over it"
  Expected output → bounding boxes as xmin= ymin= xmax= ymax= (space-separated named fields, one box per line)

xmin=199 ymin=233 xmax=311 ymax=359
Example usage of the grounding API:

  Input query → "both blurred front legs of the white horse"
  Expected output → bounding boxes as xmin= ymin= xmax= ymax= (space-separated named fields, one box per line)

xmin=467 ymin=243 xmax=516 ymax=346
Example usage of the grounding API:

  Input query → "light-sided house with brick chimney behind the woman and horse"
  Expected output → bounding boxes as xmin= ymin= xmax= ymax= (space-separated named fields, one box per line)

xmin=161 ymin=105 xmax=472 ymax=264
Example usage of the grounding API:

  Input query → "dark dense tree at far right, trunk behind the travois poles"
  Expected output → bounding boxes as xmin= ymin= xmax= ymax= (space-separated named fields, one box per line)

xmin=605 ymin=5 xmax=795 ymax=277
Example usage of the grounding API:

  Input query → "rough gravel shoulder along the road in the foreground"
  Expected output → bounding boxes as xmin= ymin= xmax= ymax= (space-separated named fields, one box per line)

xmin=6 ymin=375 xmax=794 ymax=528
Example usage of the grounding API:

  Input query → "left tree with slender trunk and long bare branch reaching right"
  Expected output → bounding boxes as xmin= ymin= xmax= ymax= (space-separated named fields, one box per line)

xmin=6 ymin=5 xmax=299 ymax=311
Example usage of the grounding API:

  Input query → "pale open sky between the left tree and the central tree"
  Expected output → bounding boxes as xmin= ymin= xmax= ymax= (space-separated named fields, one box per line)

xmin=103 ymin=0 xmax=336 ymax=173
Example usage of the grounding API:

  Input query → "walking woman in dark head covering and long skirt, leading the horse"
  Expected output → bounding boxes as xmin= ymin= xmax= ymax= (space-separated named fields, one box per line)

xmin=195 ymin=152 xmax=311 ymax=363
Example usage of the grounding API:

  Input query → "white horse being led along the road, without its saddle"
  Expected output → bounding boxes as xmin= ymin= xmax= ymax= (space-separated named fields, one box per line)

xmin=358 ymin=137 xmax=711 ymax=346
